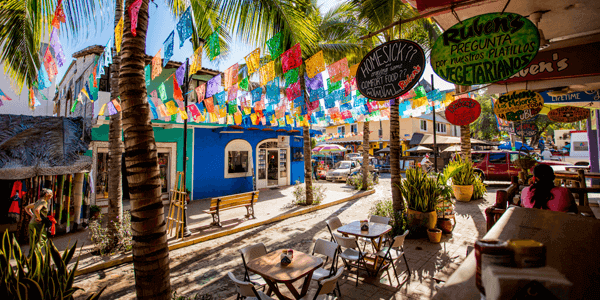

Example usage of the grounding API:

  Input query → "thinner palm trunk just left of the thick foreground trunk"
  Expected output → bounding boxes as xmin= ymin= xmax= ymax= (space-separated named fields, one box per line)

xmin=107 ymin=1 xmax=123 ymax=248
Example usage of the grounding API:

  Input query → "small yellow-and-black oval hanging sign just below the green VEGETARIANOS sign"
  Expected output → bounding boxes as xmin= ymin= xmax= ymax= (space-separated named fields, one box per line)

xmin=494 ymin=90 xmax=544 ymax=121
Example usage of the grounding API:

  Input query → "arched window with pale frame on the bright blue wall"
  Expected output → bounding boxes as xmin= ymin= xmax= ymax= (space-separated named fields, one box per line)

xmin=224 ymin=139 xmax=252 ymax=178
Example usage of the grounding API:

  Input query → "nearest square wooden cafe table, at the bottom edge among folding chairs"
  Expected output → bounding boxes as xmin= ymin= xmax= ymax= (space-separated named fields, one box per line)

xmin=247 ymin=250 xmax=323 ymax=299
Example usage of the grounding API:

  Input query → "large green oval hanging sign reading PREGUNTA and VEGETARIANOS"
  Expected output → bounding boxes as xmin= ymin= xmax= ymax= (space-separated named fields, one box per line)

xmin=431 ymin=13 xmax=540 ymax=85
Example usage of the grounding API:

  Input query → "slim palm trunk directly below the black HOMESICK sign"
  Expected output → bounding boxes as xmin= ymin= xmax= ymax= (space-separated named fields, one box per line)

xmin=390 ymin=99 xmax=404 ymax=213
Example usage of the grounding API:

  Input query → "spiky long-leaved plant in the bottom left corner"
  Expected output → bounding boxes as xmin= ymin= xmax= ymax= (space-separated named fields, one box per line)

xmin=0 ymin=229 xmax=106 ymax=300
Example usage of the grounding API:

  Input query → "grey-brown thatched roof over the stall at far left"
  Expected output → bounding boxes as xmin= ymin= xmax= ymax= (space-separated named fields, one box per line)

xmin=0 ymin=115 xmax=91 ymax=180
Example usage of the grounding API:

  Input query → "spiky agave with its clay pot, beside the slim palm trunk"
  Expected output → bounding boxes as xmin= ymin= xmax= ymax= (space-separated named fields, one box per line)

xmin=397 ymin=168 xmax=441 ymax=233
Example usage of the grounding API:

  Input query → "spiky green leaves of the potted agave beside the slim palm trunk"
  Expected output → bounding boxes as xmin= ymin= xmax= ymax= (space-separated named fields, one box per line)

xmin=397 ymin=168 xmax=443 ymax=212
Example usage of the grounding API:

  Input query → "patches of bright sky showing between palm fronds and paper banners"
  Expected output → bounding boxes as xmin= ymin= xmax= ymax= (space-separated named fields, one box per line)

xmin=57 ymin=0 xmax=454 ymax=90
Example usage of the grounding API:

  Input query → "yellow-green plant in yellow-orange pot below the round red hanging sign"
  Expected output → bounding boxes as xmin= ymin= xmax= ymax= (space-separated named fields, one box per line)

xmin=447 ymin=155 xmax=475 ymax=202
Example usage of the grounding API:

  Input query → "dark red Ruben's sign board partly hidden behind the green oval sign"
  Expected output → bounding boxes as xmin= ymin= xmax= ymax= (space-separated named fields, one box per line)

xmin=497 ymin=42 xmax=600 ymax=84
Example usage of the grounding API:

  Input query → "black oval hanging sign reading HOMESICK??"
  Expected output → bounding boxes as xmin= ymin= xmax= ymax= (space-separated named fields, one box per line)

xmin=356 ymin=40 xmax=425 ymax=100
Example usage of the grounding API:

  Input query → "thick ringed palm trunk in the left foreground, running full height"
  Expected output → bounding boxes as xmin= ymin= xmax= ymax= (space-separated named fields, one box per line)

xmin=119 ymin=0 xmax=171 ymax=299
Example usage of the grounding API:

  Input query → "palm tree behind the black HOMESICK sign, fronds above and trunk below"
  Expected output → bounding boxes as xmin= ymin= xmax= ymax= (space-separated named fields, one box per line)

xmin=352 ymin=0 xmax=437 ymax=218
